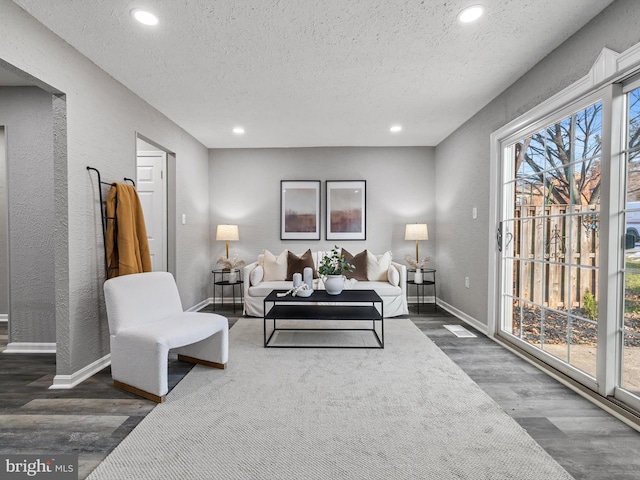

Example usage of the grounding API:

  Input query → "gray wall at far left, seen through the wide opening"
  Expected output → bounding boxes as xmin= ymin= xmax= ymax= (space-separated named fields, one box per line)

xmin=0 ymin=87 xmax=56 ymax=343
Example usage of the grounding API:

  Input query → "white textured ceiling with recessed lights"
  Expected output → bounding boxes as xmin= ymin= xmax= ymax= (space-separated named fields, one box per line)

xmin=14 ymin=0 xmax=611 ymax=148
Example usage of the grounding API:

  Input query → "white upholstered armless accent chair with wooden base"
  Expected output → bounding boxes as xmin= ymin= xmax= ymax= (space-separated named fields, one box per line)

xmin=104 ymin=272 xmax=229 ymax=403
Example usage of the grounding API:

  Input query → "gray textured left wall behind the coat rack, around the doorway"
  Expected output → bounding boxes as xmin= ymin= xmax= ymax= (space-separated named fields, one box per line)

xmin=0 ymin=0 xmax=210 ymax=376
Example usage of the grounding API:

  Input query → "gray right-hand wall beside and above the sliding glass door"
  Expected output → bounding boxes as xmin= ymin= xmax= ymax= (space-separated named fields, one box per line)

xmin=436 ymin=0 xmax=640 ymax=324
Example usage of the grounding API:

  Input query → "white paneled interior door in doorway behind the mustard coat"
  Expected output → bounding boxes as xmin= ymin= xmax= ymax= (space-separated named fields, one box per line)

xmin=136 ymin=152 xmax=167 ymax=272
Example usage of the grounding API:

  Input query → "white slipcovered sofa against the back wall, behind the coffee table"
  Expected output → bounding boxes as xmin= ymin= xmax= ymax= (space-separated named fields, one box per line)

xmin=243 ymin=251 xmax=409 ymax=318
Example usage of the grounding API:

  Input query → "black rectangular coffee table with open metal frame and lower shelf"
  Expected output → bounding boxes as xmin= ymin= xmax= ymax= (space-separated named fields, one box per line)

xmin=264 ymin=290 xmax=384 ymax=348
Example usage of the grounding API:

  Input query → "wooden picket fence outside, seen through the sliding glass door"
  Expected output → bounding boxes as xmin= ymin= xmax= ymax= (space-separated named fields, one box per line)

xmin=513 ymin=205 xmax=599 ymax=310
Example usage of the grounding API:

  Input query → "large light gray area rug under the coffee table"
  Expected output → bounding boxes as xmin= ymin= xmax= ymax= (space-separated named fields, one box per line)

xmin=89 ymin=319 xmax=572 ymax=480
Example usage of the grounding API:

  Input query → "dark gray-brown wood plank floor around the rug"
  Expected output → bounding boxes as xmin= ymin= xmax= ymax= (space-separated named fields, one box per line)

xmin=0 ymin=307 xmax=640 ymax=480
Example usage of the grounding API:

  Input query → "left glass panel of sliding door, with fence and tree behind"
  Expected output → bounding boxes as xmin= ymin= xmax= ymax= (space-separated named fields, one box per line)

xmin=498 ymin=101 xmax=604 ymax=384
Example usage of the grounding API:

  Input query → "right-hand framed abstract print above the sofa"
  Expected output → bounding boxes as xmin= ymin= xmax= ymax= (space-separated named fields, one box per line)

xmin=326 ymin=180 xmax=367 ymax=240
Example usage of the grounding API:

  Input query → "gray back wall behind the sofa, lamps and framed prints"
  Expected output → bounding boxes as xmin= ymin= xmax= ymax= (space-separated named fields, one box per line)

xmin=209 ymin=147 xmax=435 ymax=266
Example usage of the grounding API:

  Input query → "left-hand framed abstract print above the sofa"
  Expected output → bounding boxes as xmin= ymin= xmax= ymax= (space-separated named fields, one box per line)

xmin=280 ymin=180 xmax=320 ymax=240
